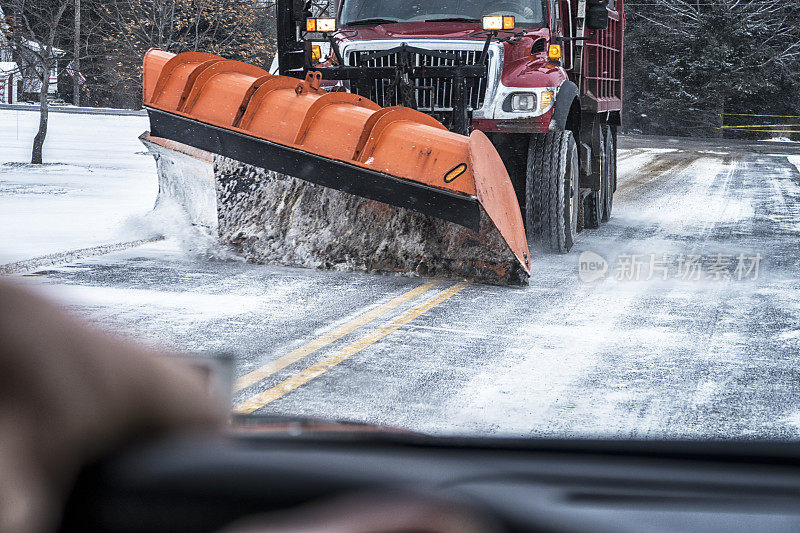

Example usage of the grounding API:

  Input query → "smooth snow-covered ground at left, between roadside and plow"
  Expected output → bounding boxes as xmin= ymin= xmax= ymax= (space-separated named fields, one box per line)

xmin=0 ymin=110 xmax=158 ymax=265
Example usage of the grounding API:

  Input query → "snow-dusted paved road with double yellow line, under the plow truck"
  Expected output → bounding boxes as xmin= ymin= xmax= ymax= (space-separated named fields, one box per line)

xmin=0 ymin=108 xmax=800 ymax=439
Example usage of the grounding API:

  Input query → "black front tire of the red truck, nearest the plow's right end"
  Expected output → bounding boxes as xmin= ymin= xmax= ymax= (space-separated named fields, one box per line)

xmin=525 ymin=131 xmax=580 ymax=253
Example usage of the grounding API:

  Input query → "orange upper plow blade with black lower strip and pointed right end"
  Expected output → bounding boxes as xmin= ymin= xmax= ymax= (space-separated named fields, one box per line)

xmin=143 ymin=50 xmax=530 ymax=279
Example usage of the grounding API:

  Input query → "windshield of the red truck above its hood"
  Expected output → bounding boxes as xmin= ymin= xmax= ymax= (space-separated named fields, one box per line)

xmin=341 ymin=0 xmax=546 ymax=27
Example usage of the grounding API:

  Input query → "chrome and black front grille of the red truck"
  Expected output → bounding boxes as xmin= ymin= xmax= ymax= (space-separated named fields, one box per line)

xmin=345 ymin=50 xmax=486 ymax=124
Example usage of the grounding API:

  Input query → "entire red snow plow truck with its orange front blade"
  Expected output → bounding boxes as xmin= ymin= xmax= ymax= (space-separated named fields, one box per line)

xmin=142 ymin=0 xmax=625 ymax=284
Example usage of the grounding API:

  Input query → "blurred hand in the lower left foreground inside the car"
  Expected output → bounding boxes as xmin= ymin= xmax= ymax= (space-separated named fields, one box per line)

xmin=0 ymin=280 xmax=225 ymax=533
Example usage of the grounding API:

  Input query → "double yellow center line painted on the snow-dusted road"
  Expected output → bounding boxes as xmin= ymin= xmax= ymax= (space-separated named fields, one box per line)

xmin=235 ymin=282 xmax=469 ymax=414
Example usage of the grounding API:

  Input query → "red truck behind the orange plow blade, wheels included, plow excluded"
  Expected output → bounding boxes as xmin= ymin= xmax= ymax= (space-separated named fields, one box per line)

xmin=278 ymin=0 xmax=624 ymax=253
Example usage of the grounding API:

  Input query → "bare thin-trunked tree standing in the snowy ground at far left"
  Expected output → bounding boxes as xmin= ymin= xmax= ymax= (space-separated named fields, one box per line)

xmin=4 ymin=0 xmax=72 ymax=164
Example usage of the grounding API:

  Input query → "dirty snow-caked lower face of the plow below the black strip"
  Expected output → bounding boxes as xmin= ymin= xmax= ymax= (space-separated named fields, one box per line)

xmin=214 ymin=157 xmax=528 ymax=285
